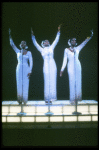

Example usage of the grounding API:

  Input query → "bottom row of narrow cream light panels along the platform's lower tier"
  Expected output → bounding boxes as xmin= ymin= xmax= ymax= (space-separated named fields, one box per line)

xmin=2 ymin=116 xmax=98 ymax=122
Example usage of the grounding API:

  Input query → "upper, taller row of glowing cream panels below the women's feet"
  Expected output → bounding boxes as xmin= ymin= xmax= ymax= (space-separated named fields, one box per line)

xmin=2 ymin=104 xmax=98 ymax=115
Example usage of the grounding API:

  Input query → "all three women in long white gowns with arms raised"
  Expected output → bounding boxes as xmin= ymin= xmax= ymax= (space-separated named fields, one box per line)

xmin=9 ymin=25 xmax=93 ymax=105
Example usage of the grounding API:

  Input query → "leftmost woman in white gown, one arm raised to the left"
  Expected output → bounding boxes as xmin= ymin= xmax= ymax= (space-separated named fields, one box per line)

xmin=9 ymin=29 xmax=33 ymax=104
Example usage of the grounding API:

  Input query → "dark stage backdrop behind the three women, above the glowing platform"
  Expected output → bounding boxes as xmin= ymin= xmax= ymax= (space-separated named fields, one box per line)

xmin=2 ymin=2 xmax=98 ymax=100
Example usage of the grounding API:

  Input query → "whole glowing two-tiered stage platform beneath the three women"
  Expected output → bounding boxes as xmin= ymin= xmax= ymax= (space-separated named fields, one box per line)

xmin=2 ymin=100 xmax=98 ymax=127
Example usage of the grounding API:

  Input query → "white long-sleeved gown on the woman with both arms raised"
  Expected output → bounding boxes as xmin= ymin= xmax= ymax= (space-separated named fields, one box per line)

xmin=32 ymin=32 xmax=60 ymax=101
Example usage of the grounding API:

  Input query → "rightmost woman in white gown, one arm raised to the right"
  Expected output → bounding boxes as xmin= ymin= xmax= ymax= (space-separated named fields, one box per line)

xmin=60 ymin=31 xmax=93 ymax=103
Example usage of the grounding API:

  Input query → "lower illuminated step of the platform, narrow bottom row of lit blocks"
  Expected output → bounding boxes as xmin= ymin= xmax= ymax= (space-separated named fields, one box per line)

xmin=2 ymin=115 xmax=98 ymax=123
